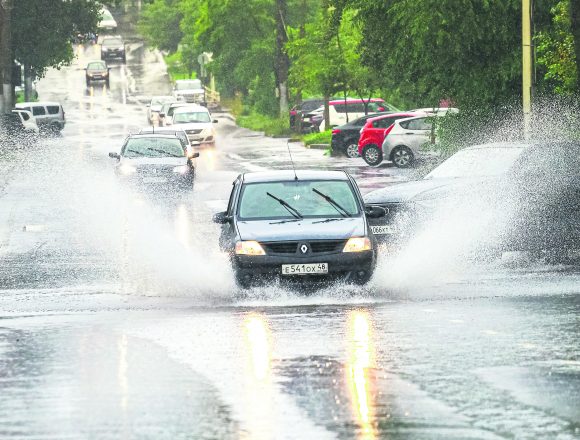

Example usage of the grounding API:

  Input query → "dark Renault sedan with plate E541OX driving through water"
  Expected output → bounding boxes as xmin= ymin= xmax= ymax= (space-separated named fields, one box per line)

xmin=214 ymin=170 xmax=384 ymax=288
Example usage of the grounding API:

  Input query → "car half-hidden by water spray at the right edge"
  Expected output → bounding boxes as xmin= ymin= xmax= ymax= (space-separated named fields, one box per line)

xmin=364 ymin=141 xmax=580 ymax=260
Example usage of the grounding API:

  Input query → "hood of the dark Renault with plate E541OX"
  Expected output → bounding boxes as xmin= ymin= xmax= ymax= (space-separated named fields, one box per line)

xmin=237 ymin=216 xmax=366 ymax=242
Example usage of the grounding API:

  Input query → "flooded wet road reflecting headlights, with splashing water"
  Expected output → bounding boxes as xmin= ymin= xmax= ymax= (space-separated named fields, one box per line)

xmin=0 ymin=14 xmax=580 ymax=440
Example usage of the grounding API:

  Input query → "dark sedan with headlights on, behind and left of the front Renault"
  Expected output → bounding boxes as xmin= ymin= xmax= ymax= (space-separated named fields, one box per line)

xmin=109 ymin=133 xmax=199 ymax=191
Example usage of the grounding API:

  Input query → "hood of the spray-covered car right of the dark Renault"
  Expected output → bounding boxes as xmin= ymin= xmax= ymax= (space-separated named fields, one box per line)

xmin=364 ymin=177 xmax=495 ymax=204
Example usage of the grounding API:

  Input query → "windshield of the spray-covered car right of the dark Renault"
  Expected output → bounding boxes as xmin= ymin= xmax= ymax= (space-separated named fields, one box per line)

xmin=425 ymin=147 xmax=524 ymax=179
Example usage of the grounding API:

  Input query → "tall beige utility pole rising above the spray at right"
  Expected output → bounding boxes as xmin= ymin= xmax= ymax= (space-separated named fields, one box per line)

xmin=522 ymin=0 xmax=532 ymax=140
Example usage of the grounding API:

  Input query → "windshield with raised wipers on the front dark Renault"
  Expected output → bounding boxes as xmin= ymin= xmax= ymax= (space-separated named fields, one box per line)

xmin=238 ymin=180 xmax=359 ymax=220
